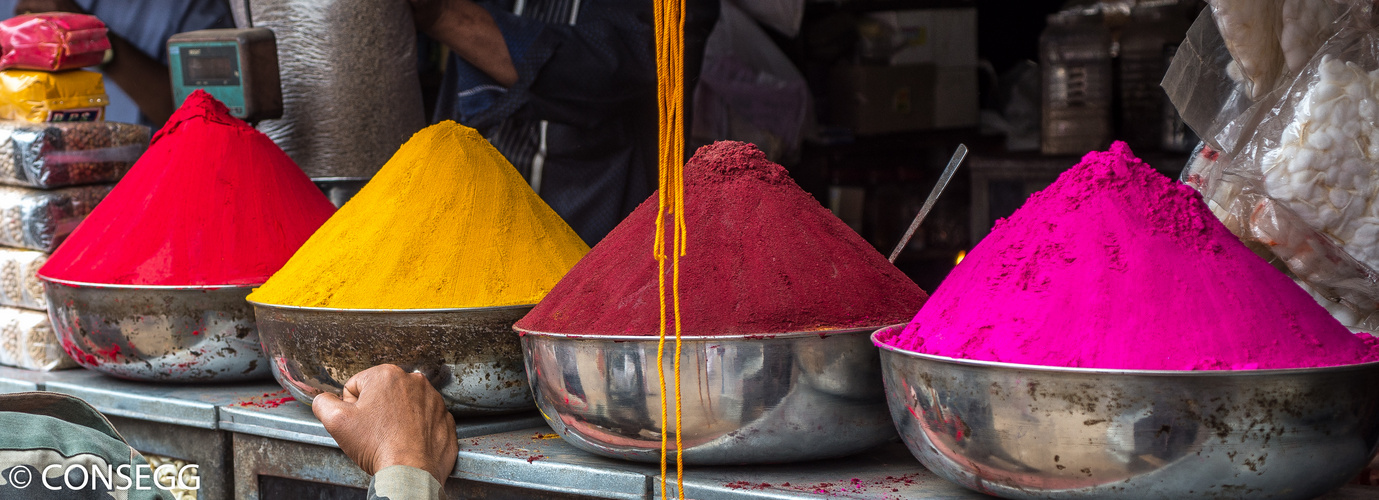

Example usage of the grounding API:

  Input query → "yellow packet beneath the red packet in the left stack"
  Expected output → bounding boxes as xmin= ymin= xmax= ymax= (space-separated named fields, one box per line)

xmin=0 ymin=69 xmax=110 ymax=123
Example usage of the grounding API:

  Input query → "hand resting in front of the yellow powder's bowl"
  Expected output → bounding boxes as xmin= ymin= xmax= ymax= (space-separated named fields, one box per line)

xmin=312 ymin=365 xmax=459 ymax=485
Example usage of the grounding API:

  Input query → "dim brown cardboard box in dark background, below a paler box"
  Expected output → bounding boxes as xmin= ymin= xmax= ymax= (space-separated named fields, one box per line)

xmin=829 ymin=65 xmax=978 ymax=135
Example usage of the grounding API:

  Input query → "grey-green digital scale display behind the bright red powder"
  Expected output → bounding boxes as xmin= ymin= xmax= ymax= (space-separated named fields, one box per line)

xmin=168 ymin=28 xmax=283 ymax=123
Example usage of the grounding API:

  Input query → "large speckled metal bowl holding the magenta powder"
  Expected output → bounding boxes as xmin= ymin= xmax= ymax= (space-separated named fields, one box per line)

xmin=873 ymin=325 xmax=1379 ymax=499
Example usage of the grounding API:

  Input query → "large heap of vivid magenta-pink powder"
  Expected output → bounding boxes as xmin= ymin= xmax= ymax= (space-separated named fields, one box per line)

xmin=881 ymin=142 xmax=1379 ymax=371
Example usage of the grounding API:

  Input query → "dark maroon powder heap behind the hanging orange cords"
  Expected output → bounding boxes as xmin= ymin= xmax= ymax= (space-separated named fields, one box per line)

xmin=517 ymin=142 xmax=925 ymax=335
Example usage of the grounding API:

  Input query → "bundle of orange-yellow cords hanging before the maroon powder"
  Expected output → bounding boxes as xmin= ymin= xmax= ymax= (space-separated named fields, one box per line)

xmin=652 ymin=0 xmax=687 ymax=500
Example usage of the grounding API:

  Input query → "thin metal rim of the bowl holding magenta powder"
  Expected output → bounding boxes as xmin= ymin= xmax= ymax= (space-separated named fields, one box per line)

xmin=872 ymin=322 xmax=1379 ymax=377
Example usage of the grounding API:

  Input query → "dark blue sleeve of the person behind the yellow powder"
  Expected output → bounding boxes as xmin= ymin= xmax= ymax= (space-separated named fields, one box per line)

xmin=447 ymin=0 xmax=656 ymax=128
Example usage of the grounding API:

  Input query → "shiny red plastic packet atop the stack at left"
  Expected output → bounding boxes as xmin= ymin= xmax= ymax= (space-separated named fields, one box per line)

xmin=0 ymin=12 xmax=110 ymax=72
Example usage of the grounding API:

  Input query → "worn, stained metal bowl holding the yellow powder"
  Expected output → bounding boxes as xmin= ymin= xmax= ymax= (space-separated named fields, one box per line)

xmin=252 ymin=302 xmax=532 ymax=416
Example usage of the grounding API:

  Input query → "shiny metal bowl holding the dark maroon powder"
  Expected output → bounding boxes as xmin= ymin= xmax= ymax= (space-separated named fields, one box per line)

xmin=519 ymin=329 xmax=895 ymax=466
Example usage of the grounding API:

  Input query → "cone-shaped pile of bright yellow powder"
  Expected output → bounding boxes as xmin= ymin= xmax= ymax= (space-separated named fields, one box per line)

xmin=250 ymin=121 xmax=589 ymax=309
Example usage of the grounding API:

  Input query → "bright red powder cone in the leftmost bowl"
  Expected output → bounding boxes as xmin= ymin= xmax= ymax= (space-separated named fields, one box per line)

xmin=39 ymin=91 xmax=335 ymax=287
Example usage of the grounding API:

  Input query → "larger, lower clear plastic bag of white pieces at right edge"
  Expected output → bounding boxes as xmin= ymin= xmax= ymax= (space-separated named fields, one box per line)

xmin=1175 ymin=10 xmax=1379 ymax=331
